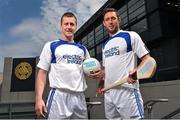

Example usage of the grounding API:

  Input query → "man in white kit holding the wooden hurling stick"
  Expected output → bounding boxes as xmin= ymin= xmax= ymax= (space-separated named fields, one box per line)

xmin=90 ymin=8 xmax=150 ymax=119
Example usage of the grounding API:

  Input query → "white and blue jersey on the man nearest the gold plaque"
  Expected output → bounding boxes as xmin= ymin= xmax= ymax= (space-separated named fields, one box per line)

xmin=37 ymin=40 xmax=90 ymax=92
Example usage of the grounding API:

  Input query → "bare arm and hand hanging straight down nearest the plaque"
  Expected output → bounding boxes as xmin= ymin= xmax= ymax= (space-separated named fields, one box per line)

xmin=35 ymin=69 xmax=47 ymax=117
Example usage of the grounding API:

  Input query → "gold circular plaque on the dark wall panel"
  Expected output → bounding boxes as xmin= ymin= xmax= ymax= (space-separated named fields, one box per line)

xmin=15 ymin=62 xmax=32 ymax=80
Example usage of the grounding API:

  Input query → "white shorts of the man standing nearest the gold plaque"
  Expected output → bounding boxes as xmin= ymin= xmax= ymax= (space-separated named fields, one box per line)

xmin=47 ymin=88 xmax=88 ymax=119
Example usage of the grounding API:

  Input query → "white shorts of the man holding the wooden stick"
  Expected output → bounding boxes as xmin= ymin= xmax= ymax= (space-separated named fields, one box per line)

xmin=104 ymin=87 xmax=144 ymax=119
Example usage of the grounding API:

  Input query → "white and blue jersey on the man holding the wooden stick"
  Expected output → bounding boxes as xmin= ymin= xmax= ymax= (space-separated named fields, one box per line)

xmin=103 ymin=30 xmax=149 ymax=88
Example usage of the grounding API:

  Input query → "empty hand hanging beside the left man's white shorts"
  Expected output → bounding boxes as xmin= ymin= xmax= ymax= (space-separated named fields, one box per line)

xmin=35 ymin=99 xmax=47 ymax=118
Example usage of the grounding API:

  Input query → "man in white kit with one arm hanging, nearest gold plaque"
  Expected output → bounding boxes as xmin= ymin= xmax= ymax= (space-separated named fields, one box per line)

xmin=35 ymin=12 xmax=90 ymax=119
